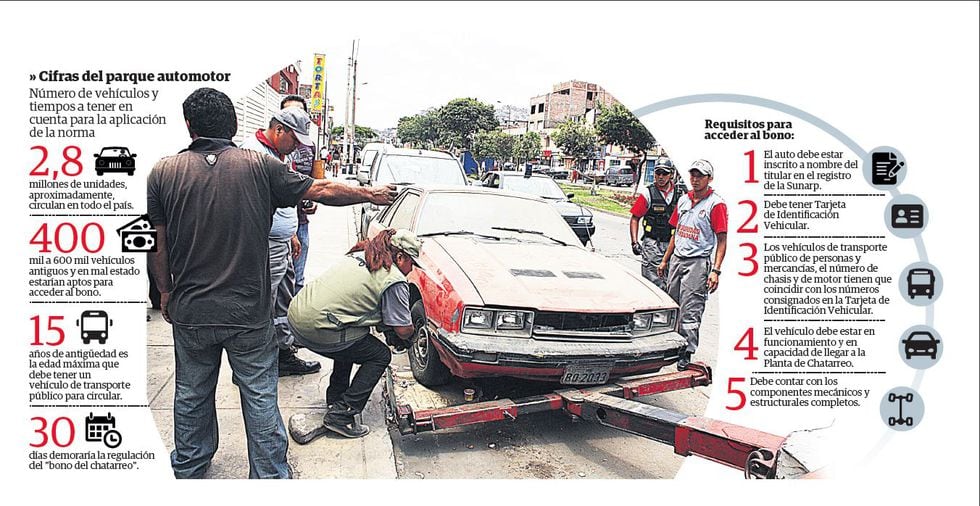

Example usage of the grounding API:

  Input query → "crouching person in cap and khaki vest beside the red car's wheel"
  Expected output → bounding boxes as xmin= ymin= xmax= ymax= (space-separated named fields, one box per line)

xmin=288 ymin=229 xmax=421 ymax=438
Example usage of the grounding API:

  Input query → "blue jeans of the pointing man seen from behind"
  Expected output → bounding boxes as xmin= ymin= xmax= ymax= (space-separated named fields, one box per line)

xmin=170 ymin=325 xmax=290 ymax=478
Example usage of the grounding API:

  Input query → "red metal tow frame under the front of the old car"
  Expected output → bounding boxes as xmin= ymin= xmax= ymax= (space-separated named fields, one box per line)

xmin=385 ymin=362 xmax=810 ymax=478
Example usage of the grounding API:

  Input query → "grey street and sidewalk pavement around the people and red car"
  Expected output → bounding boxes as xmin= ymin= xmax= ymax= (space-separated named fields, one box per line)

xmin=147 ymin=176 xmax=718 ymax=479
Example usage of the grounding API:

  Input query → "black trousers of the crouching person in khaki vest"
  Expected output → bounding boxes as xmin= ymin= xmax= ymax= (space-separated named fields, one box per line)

xmin=317 ymin=335 xmax=391 ymax=412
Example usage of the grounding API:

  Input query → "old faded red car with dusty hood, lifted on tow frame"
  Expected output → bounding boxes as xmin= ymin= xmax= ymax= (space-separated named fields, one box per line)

xmin=368 ymin=187 xmax=686 ymax=386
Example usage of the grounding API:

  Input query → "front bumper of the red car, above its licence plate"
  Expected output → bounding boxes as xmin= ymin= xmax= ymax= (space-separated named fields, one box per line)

xmin=434 ymin=329 xmax=687 ymax=381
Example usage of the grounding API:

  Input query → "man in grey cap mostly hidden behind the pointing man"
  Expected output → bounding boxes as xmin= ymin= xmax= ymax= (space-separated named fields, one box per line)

xmin=242 ymin=107 xmax=320 ymax=376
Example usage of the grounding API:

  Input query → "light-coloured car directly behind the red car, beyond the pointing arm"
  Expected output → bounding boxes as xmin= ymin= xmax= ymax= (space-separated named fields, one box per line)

xmin=357 ymin=147 xmax=467 ymax=238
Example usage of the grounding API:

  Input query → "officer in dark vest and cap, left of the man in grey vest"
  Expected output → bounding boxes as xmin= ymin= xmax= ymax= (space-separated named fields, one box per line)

xmin=630 ymin=156 xmax=684 ymax=291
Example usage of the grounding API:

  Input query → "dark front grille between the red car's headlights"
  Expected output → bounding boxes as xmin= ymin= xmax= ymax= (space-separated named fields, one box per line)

xmin=532 ymin=311 xmax=633 ymax=341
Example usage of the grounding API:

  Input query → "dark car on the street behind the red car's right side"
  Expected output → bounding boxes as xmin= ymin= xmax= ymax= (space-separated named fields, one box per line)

xmin=483 ymin=172 xmax=595 ymax=244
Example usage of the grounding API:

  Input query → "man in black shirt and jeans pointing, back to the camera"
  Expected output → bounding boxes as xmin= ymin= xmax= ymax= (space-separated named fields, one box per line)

xmin=147 ymin=88 xmax=396 ymax=478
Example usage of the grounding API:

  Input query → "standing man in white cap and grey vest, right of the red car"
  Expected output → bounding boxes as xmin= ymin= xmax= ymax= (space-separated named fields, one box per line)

xmin=657 ymin=160 xmax=728 ymax=369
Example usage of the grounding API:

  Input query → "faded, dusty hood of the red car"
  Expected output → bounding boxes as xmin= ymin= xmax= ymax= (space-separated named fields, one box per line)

xmin=425 ymin=236 xmax=677 ymax=313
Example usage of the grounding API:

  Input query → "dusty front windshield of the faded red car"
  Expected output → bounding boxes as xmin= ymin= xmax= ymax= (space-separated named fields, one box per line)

xmin=415 ymin=193 xmax=581 ymax=245
